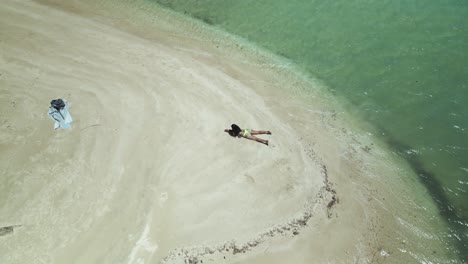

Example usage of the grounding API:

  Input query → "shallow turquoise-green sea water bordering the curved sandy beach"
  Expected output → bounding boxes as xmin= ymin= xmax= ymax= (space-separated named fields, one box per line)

xmin=151 ymin=0 xmax=468 ymax=262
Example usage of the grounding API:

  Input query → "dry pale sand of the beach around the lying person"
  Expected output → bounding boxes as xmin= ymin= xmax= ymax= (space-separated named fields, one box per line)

xmin=0 ymin=0 xmax=452 ymax=263
